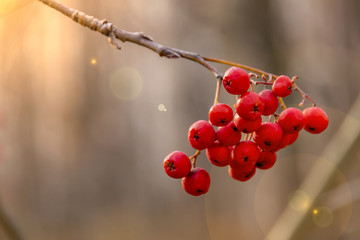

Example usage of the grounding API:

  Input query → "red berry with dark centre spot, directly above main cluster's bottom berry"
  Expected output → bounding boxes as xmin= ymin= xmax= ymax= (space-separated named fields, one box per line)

xmin=229 ymin=141 xmax=260 ymax=171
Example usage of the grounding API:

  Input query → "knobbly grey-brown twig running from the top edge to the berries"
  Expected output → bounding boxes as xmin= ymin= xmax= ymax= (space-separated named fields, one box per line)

xmin=39 ymin=0 xmax=222 ymax=79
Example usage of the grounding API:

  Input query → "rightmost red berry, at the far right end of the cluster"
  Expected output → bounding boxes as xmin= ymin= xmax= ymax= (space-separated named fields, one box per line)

xmin=303 ymin=107 xmax=329 ymax=134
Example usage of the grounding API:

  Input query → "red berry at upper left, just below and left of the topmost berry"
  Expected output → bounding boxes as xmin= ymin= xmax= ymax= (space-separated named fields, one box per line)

xmin=209 ymin=103 xmax=233 ymax=127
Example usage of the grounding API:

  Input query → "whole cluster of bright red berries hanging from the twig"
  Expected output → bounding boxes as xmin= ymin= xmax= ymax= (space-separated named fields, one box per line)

xmin=163 ymin=67 xmax=328 ymax=196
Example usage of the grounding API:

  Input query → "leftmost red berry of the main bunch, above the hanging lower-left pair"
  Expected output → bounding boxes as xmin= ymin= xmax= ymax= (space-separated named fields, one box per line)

xmin=188 ymin=120 xmax=216 ymax=150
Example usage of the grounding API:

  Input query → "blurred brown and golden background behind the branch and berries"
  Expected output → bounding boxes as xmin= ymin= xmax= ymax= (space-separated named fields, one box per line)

xmin=0 ymin=0 xmax=360 ymax=240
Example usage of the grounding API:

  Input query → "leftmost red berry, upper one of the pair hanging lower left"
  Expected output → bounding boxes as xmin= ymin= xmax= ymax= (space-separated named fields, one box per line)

xmin=164 ymin=151 xmax=191 ymax=178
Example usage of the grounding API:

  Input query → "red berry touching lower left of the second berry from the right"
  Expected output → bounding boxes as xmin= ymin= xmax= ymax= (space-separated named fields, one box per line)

xmin=253 ymin=122 xmax=283 ymax=151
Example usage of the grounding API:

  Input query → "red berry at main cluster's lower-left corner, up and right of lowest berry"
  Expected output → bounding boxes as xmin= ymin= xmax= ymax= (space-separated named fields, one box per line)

xmin=206 ymin=141 xmax=231 ymax=167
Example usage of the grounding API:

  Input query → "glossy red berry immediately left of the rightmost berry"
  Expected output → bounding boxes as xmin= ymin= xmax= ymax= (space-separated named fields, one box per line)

xmin=278 ymin=107 xmax=305 ymax=134
